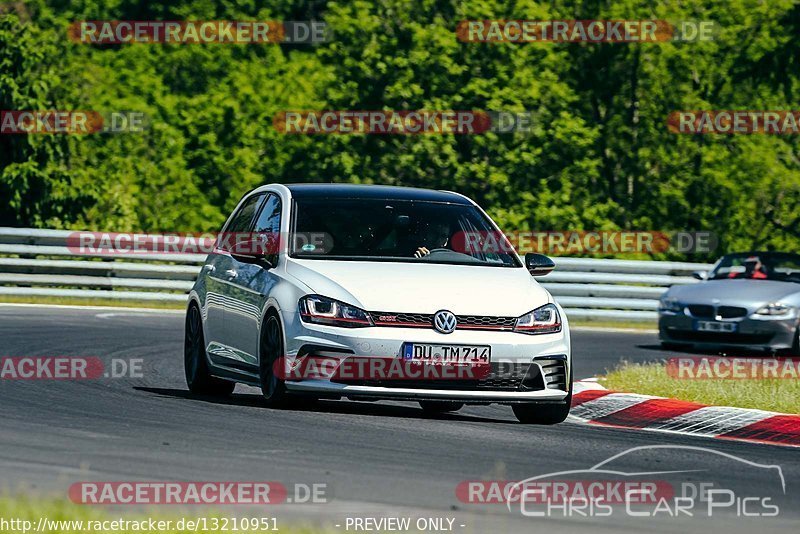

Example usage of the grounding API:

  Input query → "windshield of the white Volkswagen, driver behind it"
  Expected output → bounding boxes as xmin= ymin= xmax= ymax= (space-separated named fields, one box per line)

xmin=290 ymin=198 xmax=521 ymax=267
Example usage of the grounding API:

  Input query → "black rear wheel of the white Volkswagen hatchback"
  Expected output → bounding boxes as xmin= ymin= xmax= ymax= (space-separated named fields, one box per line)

xmin=183 ymin=303 xmax=236 ymax=396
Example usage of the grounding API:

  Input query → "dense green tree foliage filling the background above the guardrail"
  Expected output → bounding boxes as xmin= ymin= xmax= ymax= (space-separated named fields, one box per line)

xmin=0 ymin=0 xmax=800 ymax=260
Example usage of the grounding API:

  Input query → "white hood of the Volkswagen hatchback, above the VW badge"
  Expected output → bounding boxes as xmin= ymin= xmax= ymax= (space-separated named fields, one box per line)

xmin=286 ymin=259 xmax=552 ymax=317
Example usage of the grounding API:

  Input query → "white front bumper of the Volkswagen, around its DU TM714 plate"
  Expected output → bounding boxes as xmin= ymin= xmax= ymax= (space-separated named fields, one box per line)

xmin=282 ymin=312 xmax=572 ymax=404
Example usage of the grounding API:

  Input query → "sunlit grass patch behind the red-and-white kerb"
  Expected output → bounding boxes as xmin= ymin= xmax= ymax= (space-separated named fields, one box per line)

xmin=603 ymin=363 xmax=800 ymax=414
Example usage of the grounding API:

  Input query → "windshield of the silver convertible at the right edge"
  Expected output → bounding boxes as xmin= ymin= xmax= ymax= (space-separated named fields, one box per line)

xmin=709 ymin=252 xmax=800 ymax=283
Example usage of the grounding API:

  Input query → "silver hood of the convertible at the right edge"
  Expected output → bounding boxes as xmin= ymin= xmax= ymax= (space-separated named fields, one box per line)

xmin=667 ymin=280 xmax=800 ymax=307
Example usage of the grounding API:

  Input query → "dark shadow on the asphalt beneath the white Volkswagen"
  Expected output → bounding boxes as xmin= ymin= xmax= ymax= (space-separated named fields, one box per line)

xmin=133 ymin=386 xmax=518 ymax=424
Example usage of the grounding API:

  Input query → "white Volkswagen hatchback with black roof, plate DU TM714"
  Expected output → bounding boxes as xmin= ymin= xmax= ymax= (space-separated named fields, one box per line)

xmin=184 ymin=184 xmax=572 ymax=424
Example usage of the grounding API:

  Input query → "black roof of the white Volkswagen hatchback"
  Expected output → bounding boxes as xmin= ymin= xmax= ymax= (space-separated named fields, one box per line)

xmin=286 ymin=184 xmax=472 ymax=206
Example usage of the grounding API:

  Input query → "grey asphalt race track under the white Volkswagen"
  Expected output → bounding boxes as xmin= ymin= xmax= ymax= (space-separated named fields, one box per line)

xmin=0 ymin=305 xmax=800 ymax=533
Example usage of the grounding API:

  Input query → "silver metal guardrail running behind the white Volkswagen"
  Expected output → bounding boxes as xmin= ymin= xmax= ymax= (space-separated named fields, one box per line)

xmin=0 ymin=227 xmax=711 ymax=322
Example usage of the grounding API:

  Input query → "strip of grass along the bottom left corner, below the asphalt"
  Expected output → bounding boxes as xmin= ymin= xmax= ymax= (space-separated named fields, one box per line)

xmin=0 ymin=496 xmax=319 ymax=534
